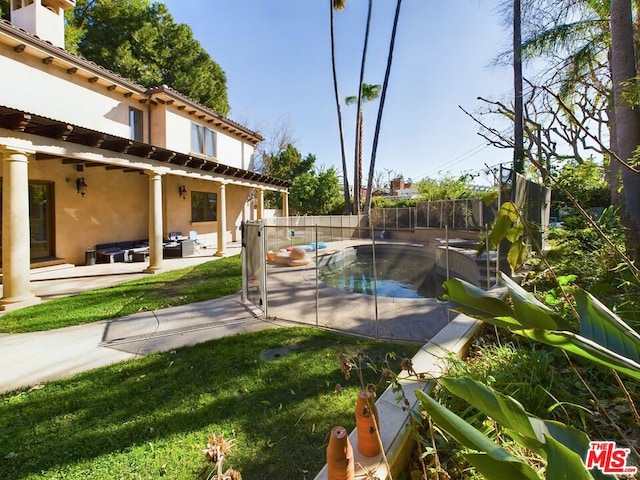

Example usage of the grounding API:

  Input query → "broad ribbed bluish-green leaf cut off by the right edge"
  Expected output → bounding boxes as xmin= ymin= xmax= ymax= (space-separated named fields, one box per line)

xmin=574 ymin=289 xmax=640 ymax=363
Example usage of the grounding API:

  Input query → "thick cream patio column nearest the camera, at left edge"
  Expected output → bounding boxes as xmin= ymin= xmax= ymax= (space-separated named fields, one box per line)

xmin=0 ymin=148 xmax=40 ymax=311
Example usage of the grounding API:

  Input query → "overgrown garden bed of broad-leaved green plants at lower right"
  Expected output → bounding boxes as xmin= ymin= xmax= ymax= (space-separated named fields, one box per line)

xmin=400 ymin=196 xmax=640 ymax=479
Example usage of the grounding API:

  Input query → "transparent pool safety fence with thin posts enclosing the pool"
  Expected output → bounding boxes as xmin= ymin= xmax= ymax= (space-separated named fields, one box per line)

xmin=242 ymin=202 xmax=498 ymax=343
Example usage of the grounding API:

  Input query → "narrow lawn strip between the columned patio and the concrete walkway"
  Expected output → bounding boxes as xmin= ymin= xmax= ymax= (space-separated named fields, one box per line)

xmin=0 ymin=255 xmax=242 ymax=333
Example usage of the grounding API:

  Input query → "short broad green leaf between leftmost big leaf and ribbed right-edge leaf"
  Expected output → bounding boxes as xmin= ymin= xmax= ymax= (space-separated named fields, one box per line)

xmin=500 ymin=272 xmax=569 ymax=330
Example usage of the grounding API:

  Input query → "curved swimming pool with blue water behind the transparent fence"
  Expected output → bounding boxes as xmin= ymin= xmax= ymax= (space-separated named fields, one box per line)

xmin=318 ymin=245 xmax=444 ymax=298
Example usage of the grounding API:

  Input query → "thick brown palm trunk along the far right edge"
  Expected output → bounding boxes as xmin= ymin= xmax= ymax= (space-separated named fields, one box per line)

xmin=611 ymin=0 xmax=640 ymax=259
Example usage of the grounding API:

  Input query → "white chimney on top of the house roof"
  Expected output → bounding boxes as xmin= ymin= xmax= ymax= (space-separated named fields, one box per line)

xmin=9 ymin=0 xmax=76 ymax=48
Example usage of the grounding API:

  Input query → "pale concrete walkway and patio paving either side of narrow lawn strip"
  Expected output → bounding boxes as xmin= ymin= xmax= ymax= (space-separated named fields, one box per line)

xmin=0 ymin=244 xmax=286 ymax=393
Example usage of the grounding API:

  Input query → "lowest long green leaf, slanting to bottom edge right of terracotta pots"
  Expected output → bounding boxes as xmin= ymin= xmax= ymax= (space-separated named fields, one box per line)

xmin=416 ymin=390 xmax=540 ymax=480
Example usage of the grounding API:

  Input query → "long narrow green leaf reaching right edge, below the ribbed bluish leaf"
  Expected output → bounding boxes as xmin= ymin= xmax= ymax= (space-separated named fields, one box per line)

xmin=515 ymin=329 xmax=640 ymax=380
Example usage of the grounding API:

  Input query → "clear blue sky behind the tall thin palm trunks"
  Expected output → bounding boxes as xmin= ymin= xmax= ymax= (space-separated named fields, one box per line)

xmin=163 ymin=0 xmax=513 ymax=183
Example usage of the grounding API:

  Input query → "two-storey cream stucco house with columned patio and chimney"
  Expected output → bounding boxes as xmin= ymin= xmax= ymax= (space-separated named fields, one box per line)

xmin=0 ymin=0 xmax=289 ymax=310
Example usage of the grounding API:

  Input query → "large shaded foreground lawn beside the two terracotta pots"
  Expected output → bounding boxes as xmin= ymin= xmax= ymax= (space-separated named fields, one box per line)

xmin=0 ymin=326 xmax=417 ymax=480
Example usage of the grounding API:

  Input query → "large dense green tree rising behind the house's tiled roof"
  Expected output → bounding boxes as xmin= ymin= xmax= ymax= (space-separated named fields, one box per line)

xmin=66 ymin=0 xmax=230 ymax=115
